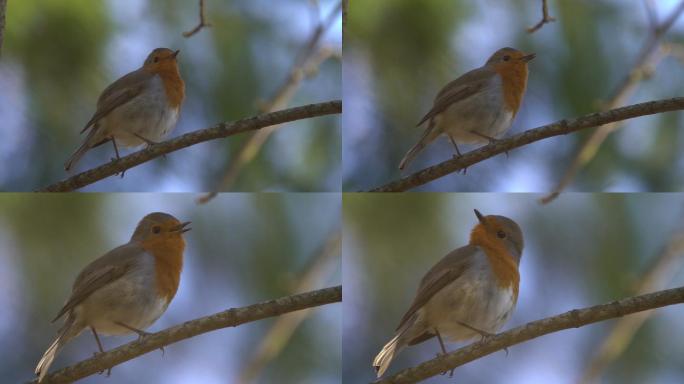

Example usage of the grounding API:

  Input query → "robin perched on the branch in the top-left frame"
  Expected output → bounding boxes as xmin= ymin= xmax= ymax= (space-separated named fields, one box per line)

xmin=64 ymin=48 xmax=185 ymax=171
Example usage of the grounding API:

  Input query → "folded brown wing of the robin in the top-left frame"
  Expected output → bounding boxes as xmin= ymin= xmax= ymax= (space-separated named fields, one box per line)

xmin=81 ymin=70 xmax=154 ymax=133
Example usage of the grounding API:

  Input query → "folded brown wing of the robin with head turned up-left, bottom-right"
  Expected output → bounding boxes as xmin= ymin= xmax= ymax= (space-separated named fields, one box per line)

xmin=397 ymin=245 xmax=479 ymax=329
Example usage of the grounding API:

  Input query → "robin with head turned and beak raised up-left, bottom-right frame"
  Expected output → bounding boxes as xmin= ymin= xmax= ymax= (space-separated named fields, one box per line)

xmin=373 ymin=210 xmax=523 ymax=377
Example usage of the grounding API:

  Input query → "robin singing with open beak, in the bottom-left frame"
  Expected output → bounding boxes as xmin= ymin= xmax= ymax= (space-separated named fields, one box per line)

xmin=35 ymin=212 xmax=190 ymax=382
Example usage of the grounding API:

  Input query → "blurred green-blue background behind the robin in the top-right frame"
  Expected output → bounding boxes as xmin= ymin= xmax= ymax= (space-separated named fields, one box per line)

xmin=342 ymin=0 xmax=684 ymax=192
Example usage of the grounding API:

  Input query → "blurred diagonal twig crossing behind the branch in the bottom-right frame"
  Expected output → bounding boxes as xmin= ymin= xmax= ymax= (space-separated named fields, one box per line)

xmin=579 ymin=214 xmax=684 ymax=383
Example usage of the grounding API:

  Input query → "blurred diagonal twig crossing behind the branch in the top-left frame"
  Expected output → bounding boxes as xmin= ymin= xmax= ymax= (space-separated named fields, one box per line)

xmin=197 ymin=1 xmax=342 ymax=204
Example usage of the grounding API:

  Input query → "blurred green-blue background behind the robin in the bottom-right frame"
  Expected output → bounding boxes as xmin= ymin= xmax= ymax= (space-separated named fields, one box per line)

xmin=342 ymin=193 xmax=684 ymax=384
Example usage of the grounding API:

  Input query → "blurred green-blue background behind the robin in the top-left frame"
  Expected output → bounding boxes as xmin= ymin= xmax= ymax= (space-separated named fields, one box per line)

xmin=0 ymin=0 xmax=342 ymax=192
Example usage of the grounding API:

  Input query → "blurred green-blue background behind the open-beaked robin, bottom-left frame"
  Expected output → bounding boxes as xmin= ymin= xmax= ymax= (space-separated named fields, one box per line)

xmin=0 ymin=193 xmax=342 ymax=384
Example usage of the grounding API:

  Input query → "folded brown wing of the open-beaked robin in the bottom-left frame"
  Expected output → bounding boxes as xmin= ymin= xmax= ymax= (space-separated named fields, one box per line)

xmin=52 ymin=243 xmax=145 ymax=322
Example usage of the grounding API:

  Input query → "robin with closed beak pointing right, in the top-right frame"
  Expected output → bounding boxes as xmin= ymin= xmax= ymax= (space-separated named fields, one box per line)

xmin=399 ymin=48 xmax=536 ymax=169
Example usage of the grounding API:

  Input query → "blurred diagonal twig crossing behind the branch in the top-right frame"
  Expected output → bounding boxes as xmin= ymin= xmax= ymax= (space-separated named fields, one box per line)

xmin=540 ymin=0 xmax=684 ymax=204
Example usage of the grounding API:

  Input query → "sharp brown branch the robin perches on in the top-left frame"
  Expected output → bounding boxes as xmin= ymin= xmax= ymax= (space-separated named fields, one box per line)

xmin=38 ymin=100 xmax=342 ymax=192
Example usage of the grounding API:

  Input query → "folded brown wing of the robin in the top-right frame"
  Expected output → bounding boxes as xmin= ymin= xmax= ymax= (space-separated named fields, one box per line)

xmin=416 ymin=68 xmax=493 ymax=126
